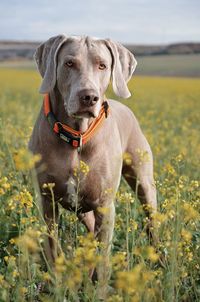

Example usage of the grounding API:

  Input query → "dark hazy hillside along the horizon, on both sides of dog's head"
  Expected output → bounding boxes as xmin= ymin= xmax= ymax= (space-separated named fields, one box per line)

xmin=0 ymin=41 xmax=200 ymax=61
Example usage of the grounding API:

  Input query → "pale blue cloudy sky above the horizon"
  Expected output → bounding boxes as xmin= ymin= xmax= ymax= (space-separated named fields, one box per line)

xmin=0 ymin=0 xmax=200 ymax=44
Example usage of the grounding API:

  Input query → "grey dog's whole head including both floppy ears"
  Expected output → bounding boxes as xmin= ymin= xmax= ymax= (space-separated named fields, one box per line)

xmin=35 ymin=35 xmax=137 ymax=117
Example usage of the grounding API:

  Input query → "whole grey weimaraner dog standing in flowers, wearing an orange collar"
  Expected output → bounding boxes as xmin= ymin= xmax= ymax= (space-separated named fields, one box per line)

xmin=29 ymin=35 xmax=157 ymax=295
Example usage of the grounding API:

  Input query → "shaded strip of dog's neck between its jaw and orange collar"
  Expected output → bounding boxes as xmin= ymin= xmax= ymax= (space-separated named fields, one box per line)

xmin=50 ymin=88 xmax=94 ymax=133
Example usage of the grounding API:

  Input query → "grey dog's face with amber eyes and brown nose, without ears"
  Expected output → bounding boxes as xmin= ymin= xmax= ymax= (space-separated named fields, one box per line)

xmin=57 ymin=38 xmax=112 ymax=117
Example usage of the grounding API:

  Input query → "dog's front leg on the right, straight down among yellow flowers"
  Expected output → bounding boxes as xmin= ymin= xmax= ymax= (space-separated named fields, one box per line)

xmin=95 ymin=201 xmax=115 ymax=299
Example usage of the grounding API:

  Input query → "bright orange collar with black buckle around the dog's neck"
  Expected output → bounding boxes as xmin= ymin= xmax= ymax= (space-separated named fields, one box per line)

xmin=44 ymin=94 xmax=110 ymax=148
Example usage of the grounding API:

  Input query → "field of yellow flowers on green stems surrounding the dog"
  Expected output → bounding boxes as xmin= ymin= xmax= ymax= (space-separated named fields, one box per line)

xmin=0 ymin=68 xmax=200 ymax=302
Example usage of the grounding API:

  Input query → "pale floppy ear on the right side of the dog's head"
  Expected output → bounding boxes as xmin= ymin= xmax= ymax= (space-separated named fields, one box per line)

xmin=105 ymin=39 xmax=137 ymax=99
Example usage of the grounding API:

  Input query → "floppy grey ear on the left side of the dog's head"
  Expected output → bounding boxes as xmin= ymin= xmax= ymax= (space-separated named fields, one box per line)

xmin=34 ymin=35 xmax=67 ymax=93
